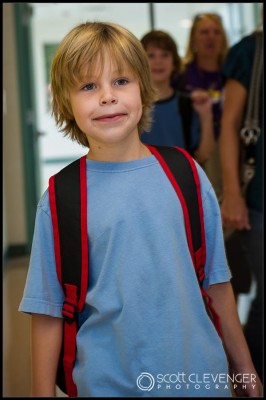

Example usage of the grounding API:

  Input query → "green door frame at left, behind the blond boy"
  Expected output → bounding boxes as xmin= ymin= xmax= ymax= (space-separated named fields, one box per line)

xmin=13 ymin=3 xmax=40 ymax=253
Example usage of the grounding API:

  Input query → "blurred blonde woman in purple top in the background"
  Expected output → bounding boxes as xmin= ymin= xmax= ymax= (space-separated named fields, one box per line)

xmin=173 ymin=13 xmax=228 ymax=199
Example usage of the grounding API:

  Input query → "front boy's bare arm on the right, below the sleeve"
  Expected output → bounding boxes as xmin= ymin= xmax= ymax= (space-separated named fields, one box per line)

xmin=206 ymin=282 xmax=263 ymax=397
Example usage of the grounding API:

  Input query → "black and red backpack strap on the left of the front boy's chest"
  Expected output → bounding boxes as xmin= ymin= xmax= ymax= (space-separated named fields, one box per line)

xmin=49 ymin=156 xmax=89 ymax=397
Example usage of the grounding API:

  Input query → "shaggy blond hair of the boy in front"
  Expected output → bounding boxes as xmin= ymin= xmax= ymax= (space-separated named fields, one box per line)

xmin=51 ymin=22 xmax=156 ymax=147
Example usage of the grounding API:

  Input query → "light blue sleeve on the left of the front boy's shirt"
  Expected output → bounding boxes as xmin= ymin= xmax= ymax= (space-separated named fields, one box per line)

xmin=19 ymin=191 xmax=64 ymax=317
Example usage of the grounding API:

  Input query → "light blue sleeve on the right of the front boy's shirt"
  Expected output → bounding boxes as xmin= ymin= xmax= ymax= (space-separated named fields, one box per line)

xmin=198 ymin=166 xmax=231 ymax=289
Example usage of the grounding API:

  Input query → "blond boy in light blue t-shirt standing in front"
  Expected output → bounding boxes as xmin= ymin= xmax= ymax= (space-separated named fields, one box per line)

xmin=19 ymin=22 xmax=261 ymax=397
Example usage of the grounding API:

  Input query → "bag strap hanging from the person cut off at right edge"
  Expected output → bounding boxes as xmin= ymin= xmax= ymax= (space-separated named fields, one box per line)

xmin=240 ymin=32 xmax=263 ymax=146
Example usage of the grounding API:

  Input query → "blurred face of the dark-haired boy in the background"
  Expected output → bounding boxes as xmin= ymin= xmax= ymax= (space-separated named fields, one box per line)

xmin=146 ymin=44 xmax=174 ymax=84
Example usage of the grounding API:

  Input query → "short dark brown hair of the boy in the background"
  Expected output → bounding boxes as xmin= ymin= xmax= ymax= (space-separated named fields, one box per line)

xmin=141 ymin=30 xmax=182 ymax=80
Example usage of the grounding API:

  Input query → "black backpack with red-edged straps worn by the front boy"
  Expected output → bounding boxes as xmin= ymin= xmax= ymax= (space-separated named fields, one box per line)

xmin=49 ymin=145 xmax=221 ymax=397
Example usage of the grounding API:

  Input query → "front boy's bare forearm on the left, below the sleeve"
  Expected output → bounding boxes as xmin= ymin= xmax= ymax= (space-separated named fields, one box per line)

xmin=31 ymin=314 xmax=63 ymax=397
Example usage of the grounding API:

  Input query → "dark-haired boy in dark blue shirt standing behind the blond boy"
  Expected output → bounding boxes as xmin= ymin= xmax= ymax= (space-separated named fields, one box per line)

xmin=141 ymin=30 xmax=214 ymax=164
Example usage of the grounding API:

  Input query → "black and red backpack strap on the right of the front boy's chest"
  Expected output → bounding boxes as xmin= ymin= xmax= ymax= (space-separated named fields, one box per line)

xmin=146 ymin=145 xmax=221 ymax=337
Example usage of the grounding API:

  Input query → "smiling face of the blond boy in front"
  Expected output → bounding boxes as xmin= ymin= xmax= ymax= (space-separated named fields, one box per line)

xmin=70 ymin=53 xmax=142 ymax=149
